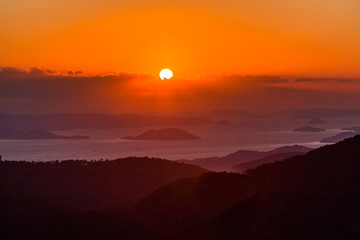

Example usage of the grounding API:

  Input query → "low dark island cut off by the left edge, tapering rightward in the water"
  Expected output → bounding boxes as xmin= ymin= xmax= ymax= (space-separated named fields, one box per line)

xmin=0 ymin=128 xmax=89 ymax=139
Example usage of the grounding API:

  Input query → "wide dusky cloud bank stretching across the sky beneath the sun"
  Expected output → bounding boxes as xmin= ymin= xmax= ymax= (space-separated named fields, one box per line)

xmin=0 ymin=67 xmax=360 ymax=113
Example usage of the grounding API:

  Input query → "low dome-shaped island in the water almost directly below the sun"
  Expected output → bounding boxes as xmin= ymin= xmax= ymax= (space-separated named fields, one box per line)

xmin=123 ymin=128 xmax=201 ymax=141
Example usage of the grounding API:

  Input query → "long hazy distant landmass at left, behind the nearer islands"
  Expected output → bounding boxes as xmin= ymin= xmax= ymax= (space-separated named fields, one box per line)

xmin=0 ymin=113 xmax=213 ymax=131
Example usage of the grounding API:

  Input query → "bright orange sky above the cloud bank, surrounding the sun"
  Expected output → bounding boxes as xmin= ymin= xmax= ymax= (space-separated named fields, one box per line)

xmin=0 ymin=0 xmax=360 ymax=78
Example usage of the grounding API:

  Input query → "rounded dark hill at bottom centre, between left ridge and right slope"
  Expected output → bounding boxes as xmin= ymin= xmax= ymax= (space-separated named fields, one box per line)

xmin=132 ymin=172 xmax=261 ymax=239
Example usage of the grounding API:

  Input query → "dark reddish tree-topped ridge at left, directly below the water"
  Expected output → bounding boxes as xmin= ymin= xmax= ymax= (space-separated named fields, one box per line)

xmin=0 ymin=157 xmax=205 ymax=210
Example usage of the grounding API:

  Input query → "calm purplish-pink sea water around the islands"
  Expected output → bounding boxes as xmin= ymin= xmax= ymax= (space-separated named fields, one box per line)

xmin=0 ymin=119 xmax=360 ymax=161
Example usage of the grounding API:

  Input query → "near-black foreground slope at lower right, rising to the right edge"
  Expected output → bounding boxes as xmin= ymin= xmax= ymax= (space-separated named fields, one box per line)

xmin=212 ymin=136 xmax=360 ymax=239
